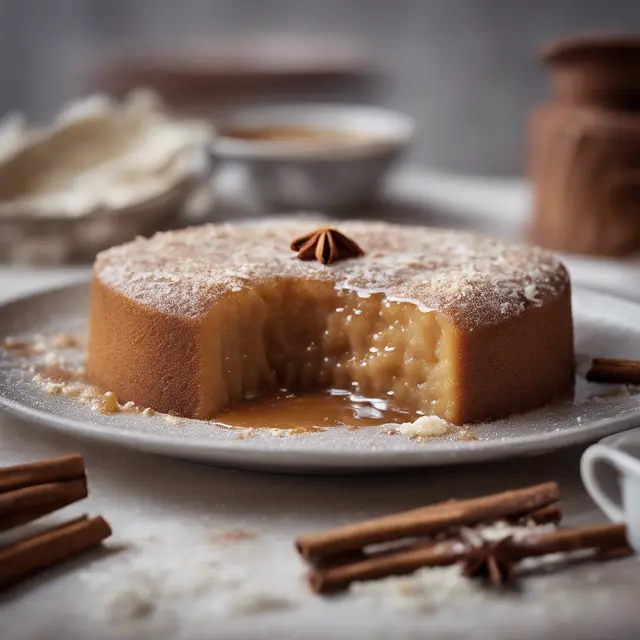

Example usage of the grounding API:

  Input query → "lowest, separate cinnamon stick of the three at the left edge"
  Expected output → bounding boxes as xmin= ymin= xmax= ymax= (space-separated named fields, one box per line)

xmin=0 ymin=516 xmax=111 ymax=588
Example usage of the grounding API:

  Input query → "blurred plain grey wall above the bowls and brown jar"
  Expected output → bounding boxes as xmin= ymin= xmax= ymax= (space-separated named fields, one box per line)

xmin=0 ymin=0 xmax=640 ymax=176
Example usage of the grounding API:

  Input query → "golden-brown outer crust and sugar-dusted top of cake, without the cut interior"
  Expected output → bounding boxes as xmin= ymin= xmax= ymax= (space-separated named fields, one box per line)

xmin=88 ymin=219 xmax=573 ymax=423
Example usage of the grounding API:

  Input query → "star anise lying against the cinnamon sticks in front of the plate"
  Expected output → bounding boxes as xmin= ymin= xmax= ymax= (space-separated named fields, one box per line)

xmin=460 ymin=528 xmax=513 ymax=586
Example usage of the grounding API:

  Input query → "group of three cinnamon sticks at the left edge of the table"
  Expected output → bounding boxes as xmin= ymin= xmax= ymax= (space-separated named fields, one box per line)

xmin=0 ymin=455 xmax=111 ymax=589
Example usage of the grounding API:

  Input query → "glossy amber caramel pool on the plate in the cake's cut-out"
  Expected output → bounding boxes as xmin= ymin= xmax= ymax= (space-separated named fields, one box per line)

xmin=216 ymin=390 xmax=418 ymax=431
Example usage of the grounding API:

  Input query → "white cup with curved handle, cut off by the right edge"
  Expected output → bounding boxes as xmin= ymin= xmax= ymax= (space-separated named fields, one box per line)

xmin=580 ymin=429 xmax=640 ymax=553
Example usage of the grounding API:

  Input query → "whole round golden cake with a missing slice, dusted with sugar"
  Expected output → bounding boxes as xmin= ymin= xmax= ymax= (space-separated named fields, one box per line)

xmin=87 ymin=218 xmax=574 ymax=424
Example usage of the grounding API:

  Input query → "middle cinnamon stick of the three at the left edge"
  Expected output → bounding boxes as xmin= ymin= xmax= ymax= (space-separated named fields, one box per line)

xmin=0 ymin=477 xmax=87 ymax=531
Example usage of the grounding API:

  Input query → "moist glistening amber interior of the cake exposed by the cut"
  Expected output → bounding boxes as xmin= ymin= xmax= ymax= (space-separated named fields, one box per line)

xmin=207 ymin=280 xmax=451 ymax=415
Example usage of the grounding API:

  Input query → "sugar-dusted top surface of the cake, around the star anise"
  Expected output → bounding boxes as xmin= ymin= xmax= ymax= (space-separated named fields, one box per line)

xmin=95 ymin=218 xmax=569 ymax=329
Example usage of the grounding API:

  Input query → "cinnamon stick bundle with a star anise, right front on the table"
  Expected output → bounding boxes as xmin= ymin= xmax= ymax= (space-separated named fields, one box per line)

xmin=296 ymin=482 xmax=632 ymax=593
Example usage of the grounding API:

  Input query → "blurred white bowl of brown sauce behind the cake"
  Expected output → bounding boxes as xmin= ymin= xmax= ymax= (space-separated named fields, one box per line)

xmin=212 ymin=104 xmax=415 ymax=212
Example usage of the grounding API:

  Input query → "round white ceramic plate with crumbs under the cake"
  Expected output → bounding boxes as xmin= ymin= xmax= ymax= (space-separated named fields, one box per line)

xmin=0 ymin=284 xmax=640 ymax=473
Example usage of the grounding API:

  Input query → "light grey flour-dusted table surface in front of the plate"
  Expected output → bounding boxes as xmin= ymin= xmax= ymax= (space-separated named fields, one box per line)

xmin=0 ymin=172 xmax=640 ymax=640
